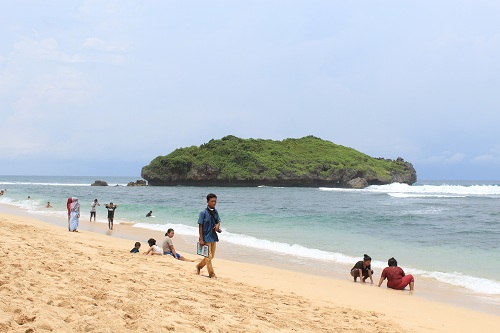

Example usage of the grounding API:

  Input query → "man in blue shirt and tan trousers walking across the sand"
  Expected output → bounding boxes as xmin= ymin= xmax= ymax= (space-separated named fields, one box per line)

xmin=196 ymin=193 xmax=221 ymax=279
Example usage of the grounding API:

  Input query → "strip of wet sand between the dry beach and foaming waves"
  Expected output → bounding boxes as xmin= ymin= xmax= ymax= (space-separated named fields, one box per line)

xmin=0 ymin=200 xmax=500 ymax=316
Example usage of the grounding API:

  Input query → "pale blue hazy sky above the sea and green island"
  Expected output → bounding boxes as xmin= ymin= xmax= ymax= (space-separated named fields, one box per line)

xmin=0 ymin=0 xmax=500 ymax=180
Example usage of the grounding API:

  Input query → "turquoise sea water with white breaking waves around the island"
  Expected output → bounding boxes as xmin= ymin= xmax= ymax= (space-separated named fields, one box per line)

xmin=0 ymin=176 xmax=500 ymax=297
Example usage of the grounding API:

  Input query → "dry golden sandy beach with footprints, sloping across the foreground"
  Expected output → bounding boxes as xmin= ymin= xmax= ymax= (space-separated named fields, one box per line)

xmin=0 ymin=214 xmax=500 ymax=332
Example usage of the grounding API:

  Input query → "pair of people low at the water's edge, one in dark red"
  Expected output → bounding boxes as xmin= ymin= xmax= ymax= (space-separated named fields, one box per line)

xmin=351 ymin=254 xmax=415 ymax=291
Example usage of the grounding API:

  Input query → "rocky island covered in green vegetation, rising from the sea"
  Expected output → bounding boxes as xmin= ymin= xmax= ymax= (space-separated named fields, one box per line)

xmin=141 ymin=135 xmax=417 ymax=188
